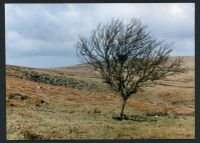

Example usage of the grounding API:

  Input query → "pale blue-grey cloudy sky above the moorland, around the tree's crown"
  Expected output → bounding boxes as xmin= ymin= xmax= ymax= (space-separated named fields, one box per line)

xmin=5 ymin=3 xmax=195 ymax=67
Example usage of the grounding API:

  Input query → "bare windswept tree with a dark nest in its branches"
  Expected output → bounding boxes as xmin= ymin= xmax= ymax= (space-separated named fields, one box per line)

xmin=76 ymin=18 xmax=184 ymax=119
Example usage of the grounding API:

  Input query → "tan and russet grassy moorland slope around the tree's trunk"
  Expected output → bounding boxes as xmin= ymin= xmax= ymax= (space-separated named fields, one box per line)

xmin=6 ymin=58 xmax=195 ymax=140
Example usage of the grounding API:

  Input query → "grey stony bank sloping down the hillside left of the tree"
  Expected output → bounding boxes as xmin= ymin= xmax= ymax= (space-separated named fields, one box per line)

xmin=6 ymin=66 xmax=105 ymax=91
